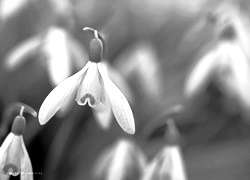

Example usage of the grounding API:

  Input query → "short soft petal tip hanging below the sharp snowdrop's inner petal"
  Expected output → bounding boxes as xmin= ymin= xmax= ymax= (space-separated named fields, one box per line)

xmin=92 ymin=101 xmax=112 ymax=129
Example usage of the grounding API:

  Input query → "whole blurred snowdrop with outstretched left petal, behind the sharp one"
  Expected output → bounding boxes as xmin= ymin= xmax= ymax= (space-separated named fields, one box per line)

xmin=4 ymin=26 xmax=86 ymax=86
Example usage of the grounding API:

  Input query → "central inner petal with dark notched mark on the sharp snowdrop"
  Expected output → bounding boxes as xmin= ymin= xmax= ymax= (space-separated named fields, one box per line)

xmin=77 ymin=62 xmax=105 ymax=107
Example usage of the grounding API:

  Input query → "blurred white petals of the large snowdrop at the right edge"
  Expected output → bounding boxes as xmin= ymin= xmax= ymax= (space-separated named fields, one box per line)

xmin=185 ymin=42 xmax=250 ymax=107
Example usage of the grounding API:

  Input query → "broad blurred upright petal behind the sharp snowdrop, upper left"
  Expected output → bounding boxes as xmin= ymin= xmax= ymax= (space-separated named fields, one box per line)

xmin=42 ymin=27 xmax=72 ymax=86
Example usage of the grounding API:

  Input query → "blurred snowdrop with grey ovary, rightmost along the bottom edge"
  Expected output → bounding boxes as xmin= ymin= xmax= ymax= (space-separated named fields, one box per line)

xmin=141 ymin=119 xmax=187 ymax=180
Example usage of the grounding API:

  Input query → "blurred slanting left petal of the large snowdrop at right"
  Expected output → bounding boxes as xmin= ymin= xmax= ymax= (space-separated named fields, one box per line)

xmin=184 ymin=47 xmax=219 ymax=98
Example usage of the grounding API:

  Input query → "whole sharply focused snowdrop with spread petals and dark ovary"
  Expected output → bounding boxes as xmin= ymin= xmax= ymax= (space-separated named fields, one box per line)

xmin=38 ymin=28 xmax=135 ymax=134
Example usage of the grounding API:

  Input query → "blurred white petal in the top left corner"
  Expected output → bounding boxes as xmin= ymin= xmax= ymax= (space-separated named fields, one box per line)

xmin=0 ymin=0 xmax=34 ymax=21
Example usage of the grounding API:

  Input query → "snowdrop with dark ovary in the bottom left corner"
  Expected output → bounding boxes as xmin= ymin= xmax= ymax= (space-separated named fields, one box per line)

xmin=0 ymin=115 xmax=33 ymax=180
